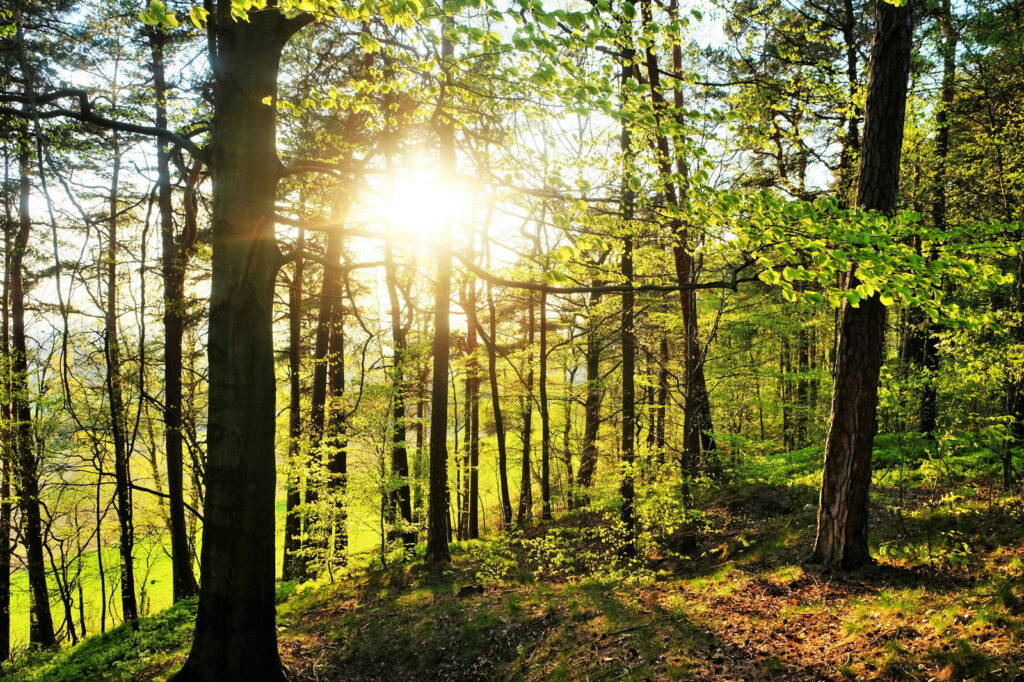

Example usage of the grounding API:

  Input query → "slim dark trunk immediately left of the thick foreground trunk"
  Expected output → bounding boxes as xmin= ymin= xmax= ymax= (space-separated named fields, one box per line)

xmin=146 ymin=29 xmax=199 ymax=601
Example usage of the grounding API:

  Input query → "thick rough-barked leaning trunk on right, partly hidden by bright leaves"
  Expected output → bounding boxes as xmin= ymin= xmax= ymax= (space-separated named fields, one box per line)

xmin=811 ymin=0 xmax=913 ymax=569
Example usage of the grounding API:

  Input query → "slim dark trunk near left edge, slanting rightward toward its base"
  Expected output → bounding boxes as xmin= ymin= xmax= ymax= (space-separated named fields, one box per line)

xmin=8 ymin=127 xmax=56 ymax=647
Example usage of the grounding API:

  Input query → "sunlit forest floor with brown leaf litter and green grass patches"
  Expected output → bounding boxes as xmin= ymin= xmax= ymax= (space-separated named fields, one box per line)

xmin=4 ymin=475 xmax=1024 ymax=682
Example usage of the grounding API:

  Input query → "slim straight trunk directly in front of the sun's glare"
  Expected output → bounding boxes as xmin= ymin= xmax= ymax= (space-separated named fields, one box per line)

xmin=426 ymin=21 xmax=456 ymax=569
